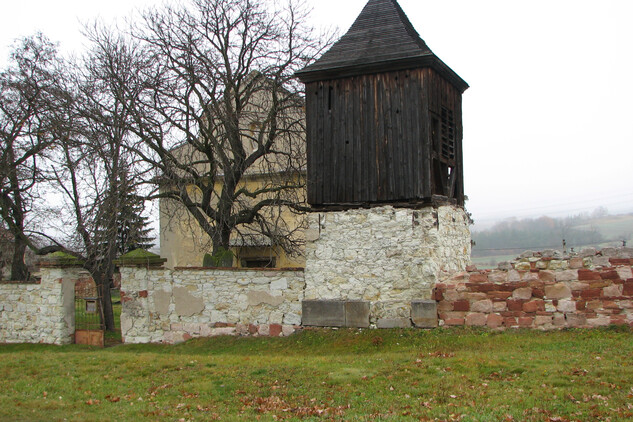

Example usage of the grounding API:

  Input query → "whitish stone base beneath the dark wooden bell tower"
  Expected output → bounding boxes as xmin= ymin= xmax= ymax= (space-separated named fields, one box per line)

xmin=305 ymin=206 xmax=471 ymax=327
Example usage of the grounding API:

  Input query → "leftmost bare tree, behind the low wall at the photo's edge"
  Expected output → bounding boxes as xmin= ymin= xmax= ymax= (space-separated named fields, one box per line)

xmin=0 ymin=34 xmax=60 ymax=280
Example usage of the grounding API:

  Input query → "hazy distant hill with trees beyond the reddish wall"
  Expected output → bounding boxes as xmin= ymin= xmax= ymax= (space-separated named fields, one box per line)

xmin=472 ymin=212 xmax=633 ymax=268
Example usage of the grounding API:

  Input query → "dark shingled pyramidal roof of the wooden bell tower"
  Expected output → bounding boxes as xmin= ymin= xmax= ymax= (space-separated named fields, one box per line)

xmin=297 ymin=0 xmax=468 ymax=92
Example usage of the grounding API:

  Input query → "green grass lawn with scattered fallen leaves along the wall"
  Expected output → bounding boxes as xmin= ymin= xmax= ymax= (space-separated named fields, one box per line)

xmin=0 ymin=328 xmax=633 ymax=421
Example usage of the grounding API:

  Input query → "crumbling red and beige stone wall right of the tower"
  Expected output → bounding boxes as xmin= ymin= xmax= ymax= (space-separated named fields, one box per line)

xmin=434 ymin=248 xmax=633 ymax=330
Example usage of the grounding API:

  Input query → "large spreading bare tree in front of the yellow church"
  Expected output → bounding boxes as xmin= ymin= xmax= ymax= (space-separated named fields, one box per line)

xmin=111 ymin=0 xmax=329 ymax=262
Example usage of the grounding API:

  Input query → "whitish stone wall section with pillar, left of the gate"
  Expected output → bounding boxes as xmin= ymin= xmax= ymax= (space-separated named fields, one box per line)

xmin=0 ymin=268 xmax=79 ymax=344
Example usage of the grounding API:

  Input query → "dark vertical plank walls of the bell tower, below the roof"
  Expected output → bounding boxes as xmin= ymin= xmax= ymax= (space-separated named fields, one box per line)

xmin=306 ymin=69 xmax=463 ymax=206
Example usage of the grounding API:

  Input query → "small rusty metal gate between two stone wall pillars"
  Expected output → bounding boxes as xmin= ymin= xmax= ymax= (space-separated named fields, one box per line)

xmin=75 ymin=277 xmax=105 ymax=347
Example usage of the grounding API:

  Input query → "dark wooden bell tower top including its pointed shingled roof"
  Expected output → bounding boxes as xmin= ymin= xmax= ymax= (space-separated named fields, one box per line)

xmin=297 ymin=0 xmax=468 ymax=210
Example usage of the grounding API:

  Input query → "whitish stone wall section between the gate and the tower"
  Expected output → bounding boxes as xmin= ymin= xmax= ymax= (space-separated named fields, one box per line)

xmin=121 ymin=267 xmax=305 ymax=343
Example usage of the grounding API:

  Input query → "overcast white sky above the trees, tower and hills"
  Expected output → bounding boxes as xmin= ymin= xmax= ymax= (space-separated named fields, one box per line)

xmin=0 ymin=0 xmax=633 ymax=224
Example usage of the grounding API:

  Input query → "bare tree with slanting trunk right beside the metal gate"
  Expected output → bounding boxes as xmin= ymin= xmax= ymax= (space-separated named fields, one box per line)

xmin=41 ymin=31 xmax=152 ymax=330
